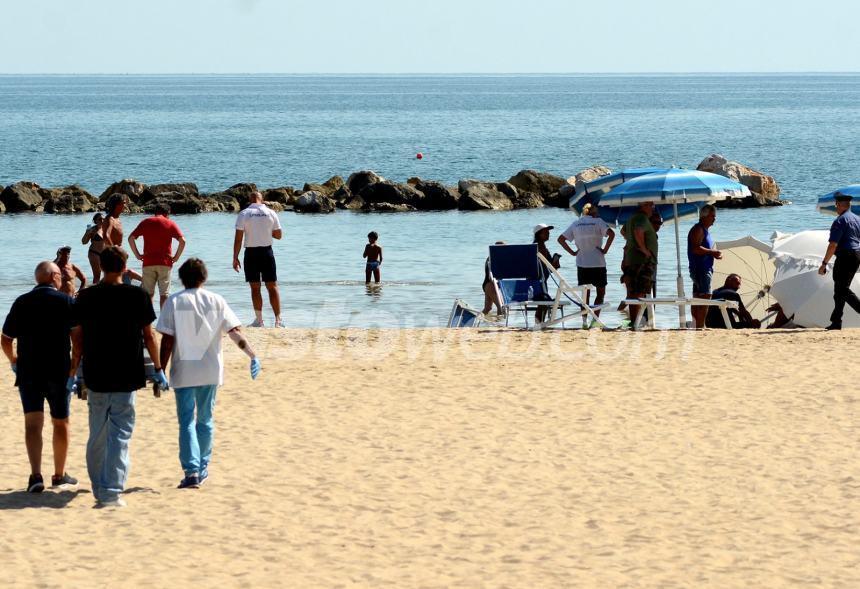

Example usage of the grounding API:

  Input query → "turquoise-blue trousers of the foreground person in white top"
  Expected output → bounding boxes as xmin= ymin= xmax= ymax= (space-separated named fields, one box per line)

xmin=175 ymin=385 xmax=218 ymax=476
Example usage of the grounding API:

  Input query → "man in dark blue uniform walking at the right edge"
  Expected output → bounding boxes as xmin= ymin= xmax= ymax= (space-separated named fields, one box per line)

xmin=818 ymin=193 xmax=860 ymax=330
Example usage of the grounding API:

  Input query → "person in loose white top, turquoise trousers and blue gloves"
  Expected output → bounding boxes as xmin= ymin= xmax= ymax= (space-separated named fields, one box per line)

xmin=156 ymin=258 xmax=261 ymax=489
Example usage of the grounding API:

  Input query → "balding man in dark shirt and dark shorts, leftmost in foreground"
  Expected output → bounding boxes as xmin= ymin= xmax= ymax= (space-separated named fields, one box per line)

xmin=0 ymin=262 xmax=78 ymax=493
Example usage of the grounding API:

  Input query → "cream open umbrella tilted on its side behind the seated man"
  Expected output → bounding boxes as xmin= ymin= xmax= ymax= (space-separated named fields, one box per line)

xmin=713 ymin=236 xmax=776 ymax=321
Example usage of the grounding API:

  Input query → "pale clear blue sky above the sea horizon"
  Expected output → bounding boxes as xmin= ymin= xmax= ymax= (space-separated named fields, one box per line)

xmin=0 ymin=0 xmax=860 ymax=74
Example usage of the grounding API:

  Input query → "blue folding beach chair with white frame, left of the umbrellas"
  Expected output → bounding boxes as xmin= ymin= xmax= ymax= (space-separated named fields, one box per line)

xmin=490 ymin=243 xmax=565 ymax=327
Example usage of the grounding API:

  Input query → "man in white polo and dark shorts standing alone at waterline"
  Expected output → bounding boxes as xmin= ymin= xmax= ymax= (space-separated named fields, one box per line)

xmin=233 ymin=192 xmax=283 ymax=327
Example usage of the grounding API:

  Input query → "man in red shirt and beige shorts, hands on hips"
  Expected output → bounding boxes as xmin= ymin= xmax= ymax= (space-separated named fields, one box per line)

xmin=128 ymin=204 xmax=185 ymax=306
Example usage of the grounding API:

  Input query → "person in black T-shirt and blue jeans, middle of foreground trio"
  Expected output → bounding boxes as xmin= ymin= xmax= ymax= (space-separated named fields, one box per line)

xmin=69 ymin=246 xmax=167 ymax=507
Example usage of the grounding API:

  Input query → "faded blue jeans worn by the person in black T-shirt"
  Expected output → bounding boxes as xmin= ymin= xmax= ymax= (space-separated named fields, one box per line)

xmin=87 ymin=391 xmax=134 ymax=501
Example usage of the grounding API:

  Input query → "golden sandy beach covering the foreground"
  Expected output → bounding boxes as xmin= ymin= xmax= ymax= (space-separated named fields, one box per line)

xmin=0 ymin=330 xmax=860 ymax=588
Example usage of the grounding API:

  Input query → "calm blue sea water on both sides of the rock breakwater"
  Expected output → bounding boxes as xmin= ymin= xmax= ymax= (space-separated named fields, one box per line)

xmin=0 ymin=75 xmax=860 ymax=326
